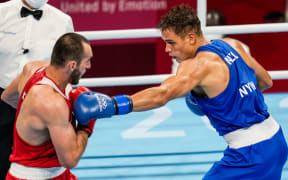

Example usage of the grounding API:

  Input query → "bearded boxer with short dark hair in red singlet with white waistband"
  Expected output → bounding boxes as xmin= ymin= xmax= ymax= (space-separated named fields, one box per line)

xmin=1 ymin=33 xmax=94 ymax=180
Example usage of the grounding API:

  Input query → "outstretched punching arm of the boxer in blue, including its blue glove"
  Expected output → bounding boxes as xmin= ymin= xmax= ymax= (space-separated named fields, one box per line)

xmin=70 ymin=58 xmax=207 ymax=118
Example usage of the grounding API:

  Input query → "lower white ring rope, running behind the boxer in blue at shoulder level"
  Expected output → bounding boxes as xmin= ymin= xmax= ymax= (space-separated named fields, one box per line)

xmin=78 ymin=71 xmax=288 ymax=87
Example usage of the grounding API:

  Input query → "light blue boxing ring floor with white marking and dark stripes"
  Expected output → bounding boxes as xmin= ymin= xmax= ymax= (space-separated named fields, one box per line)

xmin=72 ymin=93 xmax=288 ymax=180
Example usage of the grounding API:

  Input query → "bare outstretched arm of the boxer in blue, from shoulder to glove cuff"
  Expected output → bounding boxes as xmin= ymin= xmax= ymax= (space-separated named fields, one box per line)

xmin=131 ymin=59 xmax=211 ymax=111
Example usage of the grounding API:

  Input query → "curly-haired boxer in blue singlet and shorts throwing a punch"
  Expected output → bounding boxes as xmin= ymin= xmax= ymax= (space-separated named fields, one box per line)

xmin=70 ymin=5 xmax=288 ymax=180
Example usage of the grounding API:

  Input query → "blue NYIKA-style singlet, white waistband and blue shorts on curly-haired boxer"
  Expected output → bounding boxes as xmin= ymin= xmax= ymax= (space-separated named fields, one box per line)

xmin=189 ymin=40 xmax=287 ymax=180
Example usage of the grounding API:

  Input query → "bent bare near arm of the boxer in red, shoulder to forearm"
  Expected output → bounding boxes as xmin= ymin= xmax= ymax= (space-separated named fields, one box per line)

xmin=29 ymin=86 xmax=88 ymax=168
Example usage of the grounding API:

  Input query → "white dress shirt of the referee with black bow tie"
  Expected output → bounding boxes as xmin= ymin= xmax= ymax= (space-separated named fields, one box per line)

xmin=0 ymin=0 xmax=74 ymax=89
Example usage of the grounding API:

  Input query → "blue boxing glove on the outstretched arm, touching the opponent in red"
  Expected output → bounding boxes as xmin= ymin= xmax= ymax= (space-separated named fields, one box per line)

xmin=74 ymin=92 xmax=133 ymax=124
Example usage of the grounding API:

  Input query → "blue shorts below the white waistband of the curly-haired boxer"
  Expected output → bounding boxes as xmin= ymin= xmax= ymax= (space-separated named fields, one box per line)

xmin=203 ymin=117 xmax=288 ymax=180
